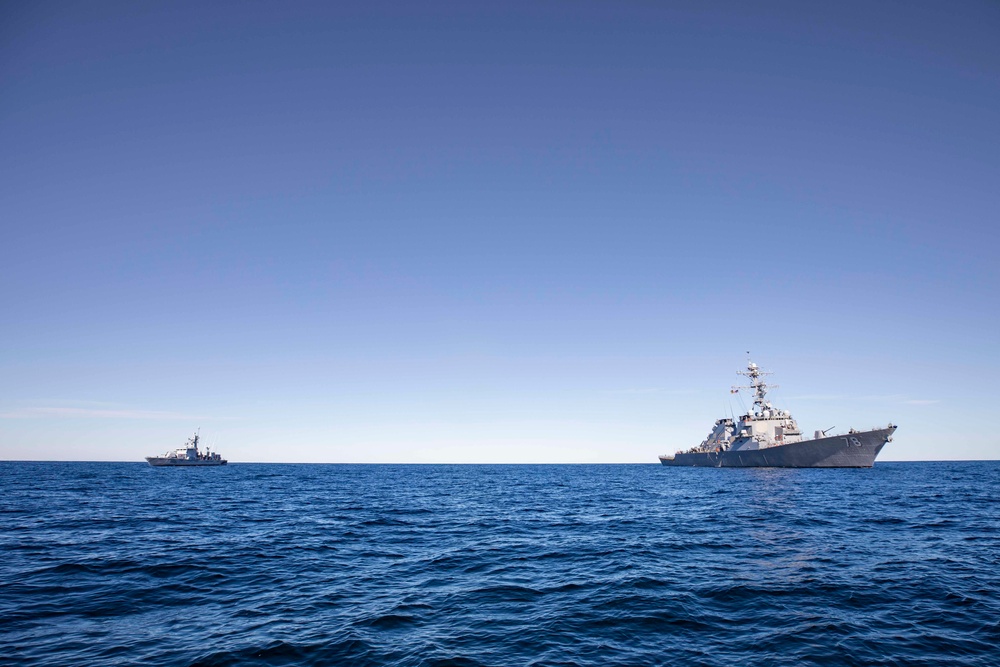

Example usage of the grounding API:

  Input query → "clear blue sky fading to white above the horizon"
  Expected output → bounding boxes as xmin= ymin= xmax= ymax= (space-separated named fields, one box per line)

xmin=0 ymin=0 xmax=1000 ymax=463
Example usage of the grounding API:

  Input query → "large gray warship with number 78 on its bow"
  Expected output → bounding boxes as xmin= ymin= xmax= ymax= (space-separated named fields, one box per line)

xmin=660 ymin=360 xmax=896 ymax=468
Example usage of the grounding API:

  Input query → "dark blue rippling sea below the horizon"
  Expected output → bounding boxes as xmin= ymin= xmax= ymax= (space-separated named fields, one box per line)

xmin=0 ymin=462 xmax=1000 ymax=667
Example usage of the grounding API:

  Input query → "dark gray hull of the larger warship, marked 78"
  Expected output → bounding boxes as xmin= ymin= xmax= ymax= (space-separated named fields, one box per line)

xmin=660 ymin=426 xmax=896 ymax=468
